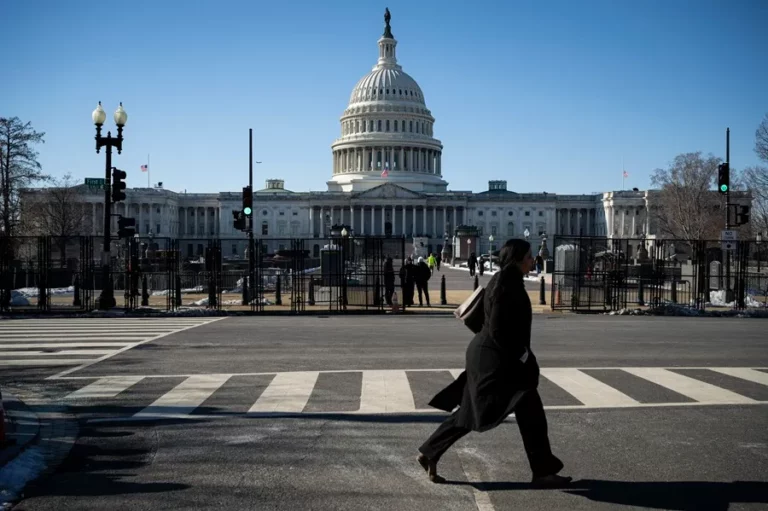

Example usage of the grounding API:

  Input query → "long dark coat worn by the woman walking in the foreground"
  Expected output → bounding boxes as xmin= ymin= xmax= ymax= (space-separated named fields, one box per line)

xmin=429 ymin=266 xmax=539 ymax=431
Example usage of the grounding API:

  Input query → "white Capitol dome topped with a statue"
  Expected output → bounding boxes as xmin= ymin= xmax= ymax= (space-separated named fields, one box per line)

xmin=328 ymin=10 xmax=448 ymax=192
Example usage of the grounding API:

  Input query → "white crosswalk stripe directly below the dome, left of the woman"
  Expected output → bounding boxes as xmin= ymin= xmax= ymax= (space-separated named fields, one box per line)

xmin=358 ymin=371 xmax=416 ymax=413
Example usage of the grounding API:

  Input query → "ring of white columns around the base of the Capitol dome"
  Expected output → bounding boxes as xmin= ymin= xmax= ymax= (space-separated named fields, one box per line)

xmin=333 ymin=146 xmax=442 ymax=176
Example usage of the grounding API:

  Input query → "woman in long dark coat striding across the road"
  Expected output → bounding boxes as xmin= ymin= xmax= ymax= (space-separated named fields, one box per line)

xmin=418 ymin=239 xmax=571 ymax=488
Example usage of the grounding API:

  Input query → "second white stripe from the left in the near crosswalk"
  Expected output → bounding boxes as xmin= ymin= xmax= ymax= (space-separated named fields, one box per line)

xmin=134 ymin=374 xmax=230 ymax=418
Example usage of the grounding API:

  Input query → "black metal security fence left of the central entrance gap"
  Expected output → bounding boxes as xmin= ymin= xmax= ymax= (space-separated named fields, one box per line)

xmin=0 ymin=236 xmax=406 ymax=313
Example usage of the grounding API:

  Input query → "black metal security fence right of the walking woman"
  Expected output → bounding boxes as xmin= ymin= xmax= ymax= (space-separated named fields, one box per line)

xmin=551 ymin=236 xmax=768 ymax=312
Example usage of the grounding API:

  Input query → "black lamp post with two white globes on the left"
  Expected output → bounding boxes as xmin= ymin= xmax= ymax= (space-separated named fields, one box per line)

xmin=91 ymin=101 xmax=128 ymax=310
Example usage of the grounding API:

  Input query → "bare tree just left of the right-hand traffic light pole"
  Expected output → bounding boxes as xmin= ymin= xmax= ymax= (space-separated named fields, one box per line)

xmin=651 ymin=152 xmax=738 ymax=242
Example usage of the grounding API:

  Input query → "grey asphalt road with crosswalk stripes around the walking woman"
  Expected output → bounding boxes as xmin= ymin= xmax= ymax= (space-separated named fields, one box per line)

xmin=6 ymin=315 xmax=768 ymax=511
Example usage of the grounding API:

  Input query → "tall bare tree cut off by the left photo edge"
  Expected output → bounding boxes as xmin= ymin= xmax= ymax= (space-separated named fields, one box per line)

xmin=0 ymin=117 xmax=49 ymax=236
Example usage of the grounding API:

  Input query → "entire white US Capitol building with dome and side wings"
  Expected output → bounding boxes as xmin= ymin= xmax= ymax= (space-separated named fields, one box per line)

xmin=36 ymin=11 xmax=672 ymax=259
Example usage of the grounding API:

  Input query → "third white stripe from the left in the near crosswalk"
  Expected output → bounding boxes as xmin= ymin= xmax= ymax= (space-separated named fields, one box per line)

xmin=248 ymin=371 xmax=320 ymax=413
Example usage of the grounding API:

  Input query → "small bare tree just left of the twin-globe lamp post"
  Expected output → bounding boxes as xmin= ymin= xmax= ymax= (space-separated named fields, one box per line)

xmin=22 ymin=174 xmax=91 ymax=266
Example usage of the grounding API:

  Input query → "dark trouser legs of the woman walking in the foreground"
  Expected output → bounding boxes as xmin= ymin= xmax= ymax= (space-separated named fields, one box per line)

xmin=419 ymin=389 xmax=563 ymax=478
